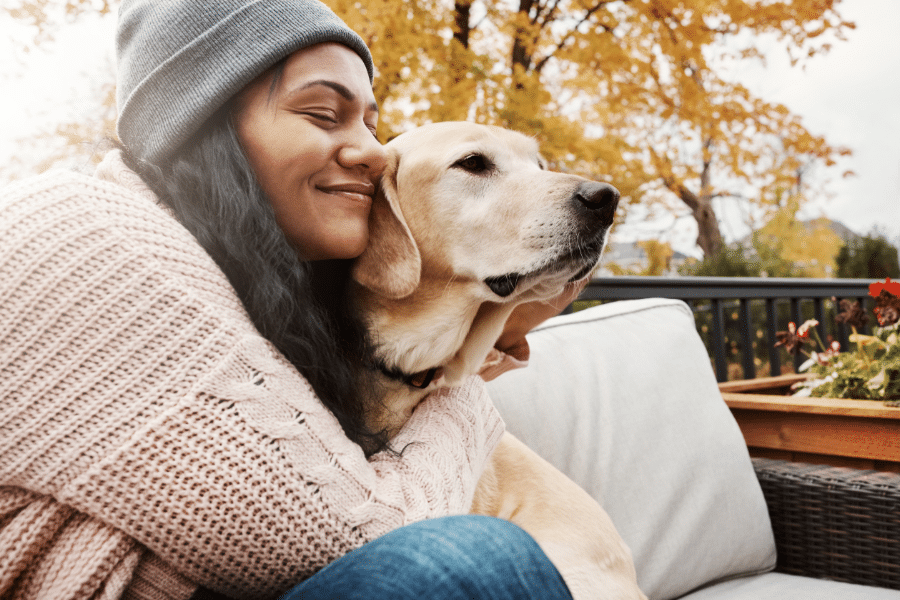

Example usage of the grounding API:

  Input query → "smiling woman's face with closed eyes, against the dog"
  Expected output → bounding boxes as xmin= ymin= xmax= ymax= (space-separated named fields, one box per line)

xmin=235 ymin=43 xmax=384 ymax=260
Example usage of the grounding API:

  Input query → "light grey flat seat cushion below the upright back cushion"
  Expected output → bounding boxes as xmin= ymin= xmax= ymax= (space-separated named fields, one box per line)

xmin=682 ymin=573 xmax=900 ymax=600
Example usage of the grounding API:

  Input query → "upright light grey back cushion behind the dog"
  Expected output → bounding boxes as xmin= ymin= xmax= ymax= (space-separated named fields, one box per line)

xmin=488 ymin=299 xmax=775 ymax=600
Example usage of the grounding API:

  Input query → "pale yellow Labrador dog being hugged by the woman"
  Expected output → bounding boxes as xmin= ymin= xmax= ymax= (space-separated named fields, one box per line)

xmin=352 ymin=122 xmax=646 ymax=600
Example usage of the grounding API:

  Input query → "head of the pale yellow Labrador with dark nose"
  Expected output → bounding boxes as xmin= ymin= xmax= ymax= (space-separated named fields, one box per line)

xmin=354 ymin=122 xmax=619 ymax=302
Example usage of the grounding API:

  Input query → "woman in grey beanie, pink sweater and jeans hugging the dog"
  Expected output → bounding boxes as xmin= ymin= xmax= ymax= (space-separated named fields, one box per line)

xmin=0 ymin=0 xmax=569 ymax=599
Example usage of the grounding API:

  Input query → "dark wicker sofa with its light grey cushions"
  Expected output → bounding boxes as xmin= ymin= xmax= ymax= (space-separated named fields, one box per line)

xmin=489 ymin=299 xmax=900 ymax=600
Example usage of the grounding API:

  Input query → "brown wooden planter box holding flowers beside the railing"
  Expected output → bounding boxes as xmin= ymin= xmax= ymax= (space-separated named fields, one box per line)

xmin=719 ymin=375 xmax=900 ymax=473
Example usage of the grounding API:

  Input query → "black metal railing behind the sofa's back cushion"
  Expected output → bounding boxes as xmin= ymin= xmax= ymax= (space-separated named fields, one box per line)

xmin=575 ymin=276 xmax=874 ymax=381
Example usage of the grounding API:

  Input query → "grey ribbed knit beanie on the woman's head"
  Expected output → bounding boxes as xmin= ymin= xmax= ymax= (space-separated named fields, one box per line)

xmin=116 ymin=0 xmax=374 ymax=163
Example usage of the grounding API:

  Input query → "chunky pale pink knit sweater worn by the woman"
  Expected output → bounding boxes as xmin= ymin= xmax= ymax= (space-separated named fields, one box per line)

xmin=0 ymin=152 xmax=503 ymax=600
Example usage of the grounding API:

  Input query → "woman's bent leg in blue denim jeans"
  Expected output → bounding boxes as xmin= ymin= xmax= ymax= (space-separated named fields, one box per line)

xmin=282 ymin=515 xmax=572 ymax=600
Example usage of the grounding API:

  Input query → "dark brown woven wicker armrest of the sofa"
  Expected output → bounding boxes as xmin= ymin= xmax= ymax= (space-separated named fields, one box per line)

xmin=753 ymin=458 xmax=900 ymax=589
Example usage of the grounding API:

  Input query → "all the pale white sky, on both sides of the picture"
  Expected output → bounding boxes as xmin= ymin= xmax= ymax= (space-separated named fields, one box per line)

xmin=0 ymin=0 xmax=900 ymax=256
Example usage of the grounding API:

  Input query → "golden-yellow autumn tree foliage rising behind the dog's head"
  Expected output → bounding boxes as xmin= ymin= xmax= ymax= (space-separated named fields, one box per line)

xmin=329 ymin=0 xmax=853 ymax=255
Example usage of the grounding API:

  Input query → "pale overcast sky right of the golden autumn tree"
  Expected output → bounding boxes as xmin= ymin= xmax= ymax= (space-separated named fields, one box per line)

xmin=614 ymin=0 xmax=900 ymax=256
